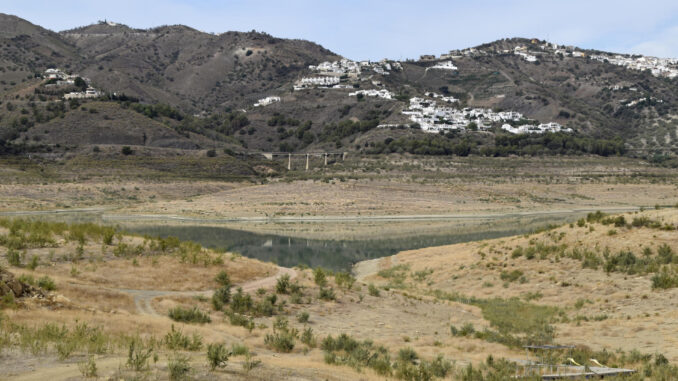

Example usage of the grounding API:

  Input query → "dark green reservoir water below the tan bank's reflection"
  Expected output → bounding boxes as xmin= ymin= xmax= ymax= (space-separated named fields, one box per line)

xmin=122 ymin=214 xmax=578 ymax=270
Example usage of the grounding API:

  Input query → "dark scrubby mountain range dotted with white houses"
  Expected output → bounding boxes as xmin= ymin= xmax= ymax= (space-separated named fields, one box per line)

xmin=0 ymin=15 xmax=678 ymax=163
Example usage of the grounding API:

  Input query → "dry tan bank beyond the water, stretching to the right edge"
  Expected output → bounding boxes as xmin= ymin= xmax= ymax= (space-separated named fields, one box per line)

xmin=111 ymin=181 xmax=678 ymax=221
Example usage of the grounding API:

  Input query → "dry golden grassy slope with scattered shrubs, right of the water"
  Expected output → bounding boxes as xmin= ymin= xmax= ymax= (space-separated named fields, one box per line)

xmin=355 ymin=209 xmax=678 ymax=361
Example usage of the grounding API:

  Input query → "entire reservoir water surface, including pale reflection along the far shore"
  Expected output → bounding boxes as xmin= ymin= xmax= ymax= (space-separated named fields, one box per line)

xmin=3 ymin=212 xmax=585 ymax=270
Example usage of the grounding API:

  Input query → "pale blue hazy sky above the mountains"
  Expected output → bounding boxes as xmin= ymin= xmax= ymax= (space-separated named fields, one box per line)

xmin=0 ymin=0 xmax=678 ymax=59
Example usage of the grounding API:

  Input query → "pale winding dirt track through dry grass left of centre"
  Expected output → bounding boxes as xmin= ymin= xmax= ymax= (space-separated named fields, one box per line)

xmin=113 ymin=267 xmax=297 ymax=316
